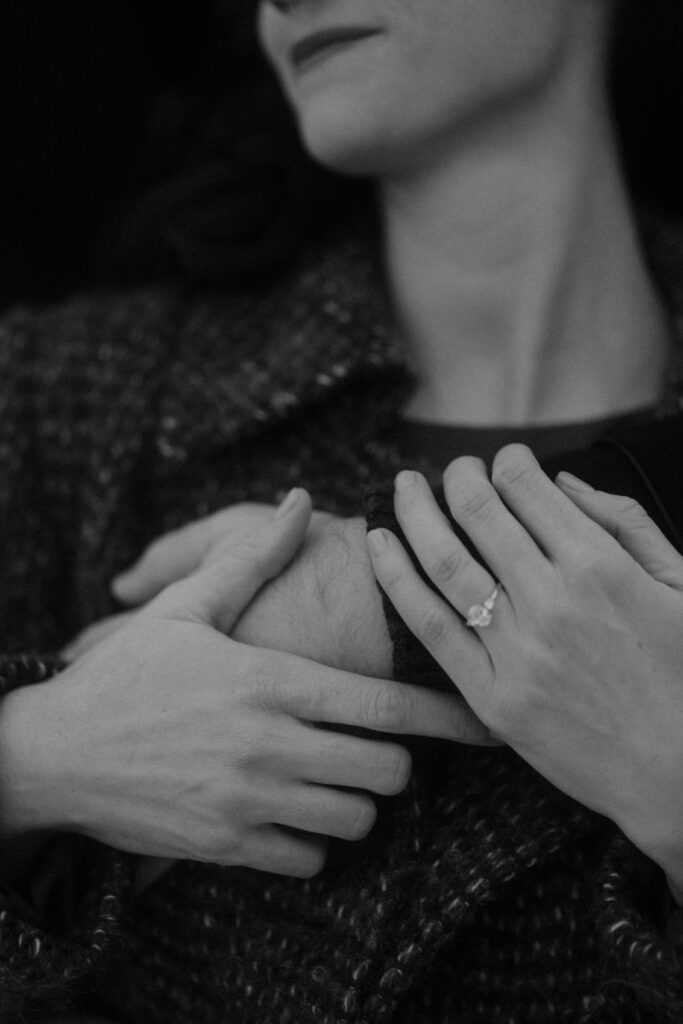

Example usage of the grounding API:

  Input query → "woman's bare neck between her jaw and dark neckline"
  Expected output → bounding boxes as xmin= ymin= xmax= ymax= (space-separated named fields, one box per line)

xmin=380 ymin=61 xmax=668 ymax=425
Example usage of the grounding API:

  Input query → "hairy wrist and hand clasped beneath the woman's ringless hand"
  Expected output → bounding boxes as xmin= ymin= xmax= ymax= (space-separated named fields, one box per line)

xmin=63 ymin=503 xmax=392 ymax=677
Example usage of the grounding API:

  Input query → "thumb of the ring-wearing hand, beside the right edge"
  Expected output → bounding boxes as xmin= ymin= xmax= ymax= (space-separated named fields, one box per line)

xmin=555 ymin=472 xmax=683 ymax=591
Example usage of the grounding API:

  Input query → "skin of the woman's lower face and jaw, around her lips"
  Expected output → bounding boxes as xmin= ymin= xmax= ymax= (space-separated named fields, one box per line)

xmin=259 ymin=0 xmax=588 ymax=175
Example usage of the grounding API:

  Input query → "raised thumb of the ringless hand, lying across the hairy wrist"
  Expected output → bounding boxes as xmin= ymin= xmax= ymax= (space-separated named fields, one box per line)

xmin=149 ymin=487 xmax=311 ymax=633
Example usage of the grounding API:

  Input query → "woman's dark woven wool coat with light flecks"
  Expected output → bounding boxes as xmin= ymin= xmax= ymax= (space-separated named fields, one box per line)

xmin=0 ymin=226 xmax=683 ymax=1024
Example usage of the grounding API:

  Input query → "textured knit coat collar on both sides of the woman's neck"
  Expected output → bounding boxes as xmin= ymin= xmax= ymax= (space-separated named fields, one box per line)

xmin=156 ymin=215 xmax=683 ymax=475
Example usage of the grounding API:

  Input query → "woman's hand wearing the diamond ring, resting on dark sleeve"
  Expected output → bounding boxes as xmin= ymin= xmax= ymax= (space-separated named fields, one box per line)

xmin=369 ymin=445 xmax=683 ymax=886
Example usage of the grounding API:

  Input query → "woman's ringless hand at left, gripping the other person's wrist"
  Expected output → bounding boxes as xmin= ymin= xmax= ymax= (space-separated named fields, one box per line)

xmin=0 ymin=492 xmax=489 ymax=877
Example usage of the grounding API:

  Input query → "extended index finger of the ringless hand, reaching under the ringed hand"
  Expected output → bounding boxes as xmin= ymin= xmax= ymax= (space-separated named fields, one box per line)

xmin=255 ymin=655 xmax=496 ymax=745
